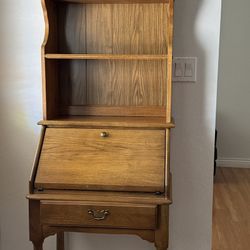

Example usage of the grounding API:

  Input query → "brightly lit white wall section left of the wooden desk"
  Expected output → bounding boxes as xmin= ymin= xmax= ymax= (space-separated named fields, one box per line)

xmin=0 ymin=0 xmax=47 ymax=250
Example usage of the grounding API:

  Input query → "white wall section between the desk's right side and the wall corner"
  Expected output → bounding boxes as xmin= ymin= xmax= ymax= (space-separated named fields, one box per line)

xmin=170 ymin=0 xmax=219 ymax=250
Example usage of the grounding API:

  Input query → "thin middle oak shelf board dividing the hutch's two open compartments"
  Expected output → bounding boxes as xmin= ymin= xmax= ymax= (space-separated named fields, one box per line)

xmin=45 ymin=54 xmax=168 ymax=60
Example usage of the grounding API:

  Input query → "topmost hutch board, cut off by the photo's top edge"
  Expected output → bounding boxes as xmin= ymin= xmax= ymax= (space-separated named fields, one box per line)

xmin=55 ymin=0 xmax=169 ymax=4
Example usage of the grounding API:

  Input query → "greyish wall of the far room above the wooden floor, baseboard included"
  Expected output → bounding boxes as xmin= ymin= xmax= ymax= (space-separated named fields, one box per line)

xmin=217 ymin=0 xmax=250 ymax=167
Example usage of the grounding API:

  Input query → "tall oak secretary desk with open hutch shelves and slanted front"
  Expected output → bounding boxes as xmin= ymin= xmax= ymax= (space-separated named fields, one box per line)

xmin=27 ymin=0 xmax=174 ymax=250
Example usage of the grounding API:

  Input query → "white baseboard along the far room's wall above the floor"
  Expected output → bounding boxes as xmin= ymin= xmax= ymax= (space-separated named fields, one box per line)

xmin=216 ymin=158 xmax=250 ymax=168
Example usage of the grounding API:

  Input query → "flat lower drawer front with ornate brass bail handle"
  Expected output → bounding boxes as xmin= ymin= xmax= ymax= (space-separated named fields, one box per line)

xmin=41 ymin=201 xmax=157 ymax=229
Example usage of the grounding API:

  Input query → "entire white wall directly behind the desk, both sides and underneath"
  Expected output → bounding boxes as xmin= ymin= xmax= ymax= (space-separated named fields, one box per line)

xmin=0 ymin=0 xmax=220 ymax=250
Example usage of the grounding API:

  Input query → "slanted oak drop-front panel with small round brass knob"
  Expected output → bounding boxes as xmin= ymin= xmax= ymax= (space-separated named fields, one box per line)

xmin=35 ymin=128 xmax=165 ymax=192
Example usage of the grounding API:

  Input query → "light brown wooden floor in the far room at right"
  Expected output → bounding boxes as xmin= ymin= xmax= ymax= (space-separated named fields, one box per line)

xmin=213 ymin=168 xmax=250 ymax=250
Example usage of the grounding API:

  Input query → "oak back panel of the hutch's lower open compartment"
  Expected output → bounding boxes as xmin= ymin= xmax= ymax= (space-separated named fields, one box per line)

xmin=58 ymin=60 xmax=167 ymax=110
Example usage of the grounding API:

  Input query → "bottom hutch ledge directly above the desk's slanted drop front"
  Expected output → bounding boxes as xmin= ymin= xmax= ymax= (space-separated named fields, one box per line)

xmin=38 ymin=116 xmax=175 ymax=128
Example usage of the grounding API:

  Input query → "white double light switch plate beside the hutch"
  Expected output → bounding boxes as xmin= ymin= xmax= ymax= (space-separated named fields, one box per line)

xmin=173 ymin=57 xmax=197 ymax=82
